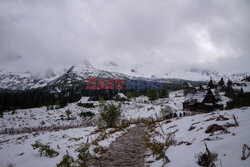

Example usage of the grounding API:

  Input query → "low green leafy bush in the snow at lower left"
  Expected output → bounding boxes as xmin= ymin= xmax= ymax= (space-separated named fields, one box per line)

xmin=31 ymin=141 xmax=59 ymax=158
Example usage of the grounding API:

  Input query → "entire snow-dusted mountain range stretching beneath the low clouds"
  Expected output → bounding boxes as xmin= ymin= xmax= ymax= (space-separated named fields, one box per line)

xmin=0 ymin=61 xmax=249 ymax=90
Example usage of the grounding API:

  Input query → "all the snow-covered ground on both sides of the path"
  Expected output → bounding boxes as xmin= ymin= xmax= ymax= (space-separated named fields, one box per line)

xmin=0 ymin=84 xmax=250 ymax=167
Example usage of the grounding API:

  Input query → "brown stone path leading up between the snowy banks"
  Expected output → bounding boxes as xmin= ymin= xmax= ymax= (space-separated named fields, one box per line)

xmin=91 ymin=126 xmax=146 ymax=167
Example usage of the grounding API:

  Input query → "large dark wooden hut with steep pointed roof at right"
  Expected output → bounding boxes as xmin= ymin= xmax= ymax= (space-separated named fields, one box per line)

xmin=183 ymin=89 xmax=223 ymax=112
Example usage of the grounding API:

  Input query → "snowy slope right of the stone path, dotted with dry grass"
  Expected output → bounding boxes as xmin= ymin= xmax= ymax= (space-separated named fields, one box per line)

xmin=147 ymin=107 xmax=250 ymax=167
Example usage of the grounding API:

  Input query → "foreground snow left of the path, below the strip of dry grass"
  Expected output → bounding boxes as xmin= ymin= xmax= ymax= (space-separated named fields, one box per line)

xmin=0 ymin=125 xmax=137 ymax=167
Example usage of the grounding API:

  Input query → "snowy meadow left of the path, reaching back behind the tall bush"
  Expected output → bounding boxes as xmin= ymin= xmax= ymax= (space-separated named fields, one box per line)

xmin=0 ymin=96 xmax=168 ymax=167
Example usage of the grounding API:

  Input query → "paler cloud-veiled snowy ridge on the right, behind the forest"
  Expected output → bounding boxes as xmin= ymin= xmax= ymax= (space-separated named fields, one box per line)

xmin=105 ymin=63 xmax=250 ymax=81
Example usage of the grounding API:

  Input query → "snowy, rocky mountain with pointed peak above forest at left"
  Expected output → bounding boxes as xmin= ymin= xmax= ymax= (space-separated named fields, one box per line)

xmin=0 ymin=62 xmax=129 ymax=90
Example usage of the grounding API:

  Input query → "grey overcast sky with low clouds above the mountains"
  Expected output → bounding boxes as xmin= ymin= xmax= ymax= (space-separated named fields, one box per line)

xmin=0 ymin=0 xmax=250 ymax=73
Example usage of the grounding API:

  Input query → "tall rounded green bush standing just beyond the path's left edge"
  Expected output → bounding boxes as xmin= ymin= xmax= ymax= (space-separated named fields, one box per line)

xmin=100 ymin=103 xmax=121 ymax=128
